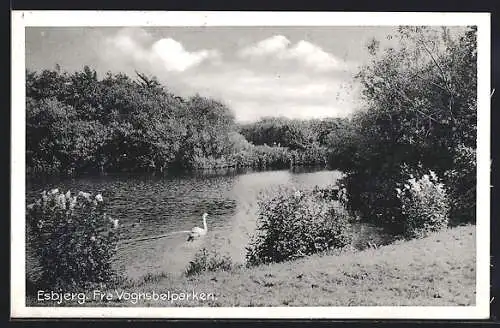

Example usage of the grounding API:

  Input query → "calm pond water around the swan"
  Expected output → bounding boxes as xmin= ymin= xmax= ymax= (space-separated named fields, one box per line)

xmin=26 ymin=169 xmax=390 ymax=278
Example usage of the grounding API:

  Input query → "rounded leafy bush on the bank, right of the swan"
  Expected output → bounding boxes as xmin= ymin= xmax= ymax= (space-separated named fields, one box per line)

xmin=246 ymin=189 xmax=351 ymax=266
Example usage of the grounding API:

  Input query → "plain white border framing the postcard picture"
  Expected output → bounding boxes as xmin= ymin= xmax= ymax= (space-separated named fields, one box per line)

xmin=10 ymin=11 xmax=491 ymax=319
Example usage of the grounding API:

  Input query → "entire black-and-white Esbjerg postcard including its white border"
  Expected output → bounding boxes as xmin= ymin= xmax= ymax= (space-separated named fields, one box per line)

xmin=11 ymin=11 xmax=494 ymax=318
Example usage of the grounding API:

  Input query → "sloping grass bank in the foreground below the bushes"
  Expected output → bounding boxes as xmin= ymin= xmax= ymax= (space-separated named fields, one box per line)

xmin=28 ymin=225 xmax=476 ymax=307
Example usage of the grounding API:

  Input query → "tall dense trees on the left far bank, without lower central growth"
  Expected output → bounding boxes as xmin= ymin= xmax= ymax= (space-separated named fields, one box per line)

xmin=26 ymin=67 xmax=234 ymax=172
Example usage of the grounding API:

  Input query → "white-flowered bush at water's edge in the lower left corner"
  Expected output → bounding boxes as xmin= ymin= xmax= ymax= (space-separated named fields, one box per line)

xmin=26 ymin=189 xmax=118 ymax=288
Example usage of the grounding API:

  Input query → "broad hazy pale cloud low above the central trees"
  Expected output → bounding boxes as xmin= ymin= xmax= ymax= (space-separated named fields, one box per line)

xmin=183 ymin=68 xmax=353 ymax=121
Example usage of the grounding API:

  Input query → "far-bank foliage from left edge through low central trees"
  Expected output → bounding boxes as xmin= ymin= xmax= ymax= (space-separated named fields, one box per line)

xmin=26 ymin=66 xmax=338 ymax=174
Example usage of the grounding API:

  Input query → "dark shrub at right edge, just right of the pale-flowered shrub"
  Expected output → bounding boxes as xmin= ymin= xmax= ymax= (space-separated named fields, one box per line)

xmin=445 ymin=145 xmax=476 ymax=224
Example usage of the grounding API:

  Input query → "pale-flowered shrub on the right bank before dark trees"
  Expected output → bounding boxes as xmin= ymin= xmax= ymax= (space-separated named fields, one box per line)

xmin=396 ymin=171 xmax=449 ymax=238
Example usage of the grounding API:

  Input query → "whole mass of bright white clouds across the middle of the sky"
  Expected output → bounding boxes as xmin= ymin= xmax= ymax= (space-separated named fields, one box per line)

xmin=101 ymin=29 xmax=360 ymax=120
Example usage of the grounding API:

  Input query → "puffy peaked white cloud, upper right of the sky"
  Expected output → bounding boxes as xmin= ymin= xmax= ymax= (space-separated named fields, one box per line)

xmin=238 ymin=35 xmax=350 ymax=71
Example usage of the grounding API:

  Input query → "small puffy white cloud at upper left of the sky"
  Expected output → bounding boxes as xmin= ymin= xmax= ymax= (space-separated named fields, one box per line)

xmin=108 ymin=29 xmax=219 ymax=72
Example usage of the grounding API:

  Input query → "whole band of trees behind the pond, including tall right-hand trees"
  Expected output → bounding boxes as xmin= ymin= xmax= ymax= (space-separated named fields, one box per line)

xmin=26 ymin=26 xmax=477 ymax=228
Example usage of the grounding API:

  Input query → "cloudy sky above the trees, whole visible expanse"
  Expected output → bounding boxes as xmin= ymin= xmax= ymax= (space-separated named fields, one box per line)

xmin=26 ymin=26 xmax=395 ymax=122
